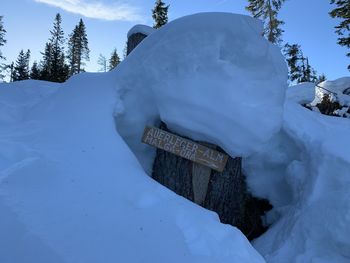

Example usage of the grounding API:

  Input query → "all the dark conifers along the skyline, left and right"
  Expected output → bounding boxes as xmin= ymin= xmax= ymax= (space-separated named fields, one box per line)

xmin=0 ymin=0 xmax=350 ymax=83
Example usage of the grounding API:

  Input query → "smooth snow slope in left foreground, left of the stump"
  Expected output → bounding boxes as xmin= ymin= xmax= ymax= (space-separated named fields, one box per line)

xmin=0 ymin=77 xmax=264 ymax=263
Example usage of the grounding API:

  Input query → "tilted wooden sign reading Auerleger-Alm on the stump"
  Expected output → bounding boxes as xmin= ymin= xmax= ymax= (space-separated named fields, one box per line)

xmin=142 ymin=127 xmax=228 ymax=172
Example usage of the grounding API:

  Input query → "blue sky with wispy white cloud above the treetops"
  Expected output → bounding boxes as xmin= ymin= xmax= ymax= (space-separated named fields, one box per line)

xmin=0 ymin=0 xmax=349 ymax=79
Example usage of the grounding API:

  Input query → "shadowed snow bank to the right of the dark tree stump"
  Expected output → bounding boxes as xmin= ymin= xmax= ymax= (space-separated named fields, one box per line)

xmin=244 ymin=79 xmax=350 ymax=262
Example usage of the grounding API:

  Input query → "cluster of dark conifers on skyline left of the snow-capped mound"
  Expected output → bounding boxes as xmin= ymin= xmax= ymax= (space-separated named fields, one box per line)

xmin=0 ymin=13 xmax=120 ymax=82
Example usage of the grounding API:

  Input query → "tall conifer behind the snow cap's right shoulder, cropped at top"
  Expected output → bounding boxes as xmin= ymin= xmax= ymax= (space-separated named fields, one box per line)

xmin=246 ymin=0 xmax=285 ymax=44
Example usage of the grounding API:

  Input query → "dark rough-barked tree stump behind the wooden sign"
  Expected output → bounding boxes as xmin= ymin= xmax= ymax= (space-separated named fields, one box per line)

xmin=152 ymin=123 xmax=271 ymax=240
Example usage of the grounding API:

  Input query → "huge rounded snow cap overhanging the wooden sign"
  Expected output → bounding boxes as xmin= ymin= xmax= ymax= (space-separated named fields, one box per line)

xmin=114 ymin=13 xmax=287 ymax=172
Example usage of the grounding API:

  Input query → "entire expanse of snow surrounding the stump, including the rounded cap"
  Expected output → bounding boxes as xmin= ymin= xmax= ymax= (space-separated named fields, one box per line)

xmin=0 ymin=11 xmax=350 ymax=263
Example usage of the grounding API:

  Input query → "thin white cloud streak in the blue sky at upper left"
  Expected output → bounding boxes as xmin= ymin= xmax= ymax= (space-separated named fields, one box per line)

xmin=34 ymin=0 xmax=142 ymax=21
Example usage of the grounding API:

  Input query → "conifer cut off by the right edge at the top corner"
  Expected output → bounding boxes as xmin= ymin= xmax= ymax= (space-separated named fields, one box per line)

xmin=329 ymin=0 xmax=350 ymax=70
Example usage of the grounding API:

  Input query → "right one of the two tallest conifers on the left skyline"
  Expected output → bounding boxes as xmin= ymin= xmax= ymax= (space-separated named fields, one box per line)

xmin=68 ymin=19 xmax=90 ymax=76
